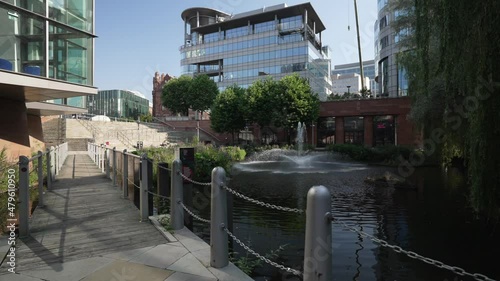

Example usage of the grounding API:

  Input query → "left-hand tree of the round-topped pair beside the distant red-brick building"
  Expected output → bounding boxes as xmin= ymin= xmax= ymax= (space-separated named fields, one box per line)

xmin=162 ymin=75 xmax=193 ymax=116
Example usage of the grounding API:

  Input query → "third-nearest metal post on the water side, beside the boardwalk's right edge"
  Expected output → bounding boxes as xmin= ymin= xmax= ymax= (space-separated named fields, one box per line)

xmin=170 ymin=159 xmax=184 ymax=230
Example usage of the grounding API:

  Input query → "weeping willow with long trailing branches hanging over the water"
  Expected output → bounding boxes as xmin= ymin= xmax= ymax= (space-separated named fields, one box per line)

xmin=391 ymin=0 xmax=500 ymax=218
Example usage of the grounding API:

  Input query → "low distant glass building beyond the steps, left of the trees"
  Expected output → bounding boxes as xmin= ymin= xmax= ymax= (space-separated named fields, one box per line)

xmin=87 ymin=90 xmax=149 ymax=120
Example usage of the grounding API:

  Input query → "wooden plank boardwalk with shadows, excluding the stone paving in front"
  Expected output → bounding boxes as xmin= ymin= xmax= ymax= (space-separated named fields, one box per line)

xmin=2 ymin=154 xmax=168 ymax=271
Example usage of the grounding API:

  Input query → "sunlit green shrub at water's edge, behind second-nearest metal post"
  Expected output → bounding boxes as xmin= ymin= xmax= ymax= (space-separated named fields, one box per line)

xmin=194 ymin=146 xmax=246 ymax=182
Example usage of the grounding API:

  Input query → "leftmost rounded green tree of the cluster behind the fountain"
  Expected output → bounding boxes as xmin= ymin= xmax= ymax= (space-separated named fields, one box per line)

xmin=210 ymin=86 xmax=247 ymax=143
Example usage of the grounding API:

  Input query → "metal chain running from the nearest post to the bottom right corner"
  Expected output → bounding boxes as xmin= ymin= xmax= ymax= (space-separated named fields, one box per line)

xmin=332 ymin=219 xmax=495 ymax=281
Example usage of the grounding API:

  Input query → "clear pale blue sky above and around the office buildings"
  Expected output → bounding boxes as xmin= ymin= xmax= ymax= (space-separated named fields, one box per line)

xmin=94 ymin=0 xmax=377 ymax=101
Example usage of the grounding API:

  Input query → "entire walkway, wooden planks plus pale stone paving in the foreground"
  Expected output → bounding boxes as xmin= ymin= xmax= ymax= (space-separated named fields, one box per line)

xmin=0 ymin=154 xmax=252 ymax=281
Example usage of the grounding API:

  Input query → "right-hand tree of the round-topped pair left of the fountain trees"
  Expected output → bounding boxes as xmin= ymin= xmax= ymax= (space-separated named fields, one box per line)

xmin=188 ymin=75 xmax=219 ymax=114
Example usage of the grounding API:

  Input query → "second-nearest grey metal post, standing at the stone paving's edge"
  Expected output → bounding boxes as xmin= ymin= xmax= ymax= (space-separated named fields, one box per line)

xmin=210 ymin=167 xmax=229 ymax=268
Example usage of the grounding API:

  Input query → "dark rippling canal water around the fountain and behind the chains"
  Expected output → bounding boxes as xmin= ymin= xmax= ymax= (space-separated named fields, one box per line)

xmin=190 ymin=153 xmax=500 ymax=281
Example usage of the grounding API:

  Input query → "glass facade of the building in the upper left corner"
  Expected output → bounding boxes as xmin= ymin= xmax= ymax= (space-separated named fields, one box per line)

xmin=0 ymin=0 xmax=95 ymax=107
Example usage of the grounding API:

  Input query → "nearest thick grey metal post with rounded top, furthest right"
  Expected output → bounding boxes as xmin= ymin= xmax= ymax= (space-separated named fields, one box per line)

xmin=304 ymin=185 xmax=332 ymax=281
